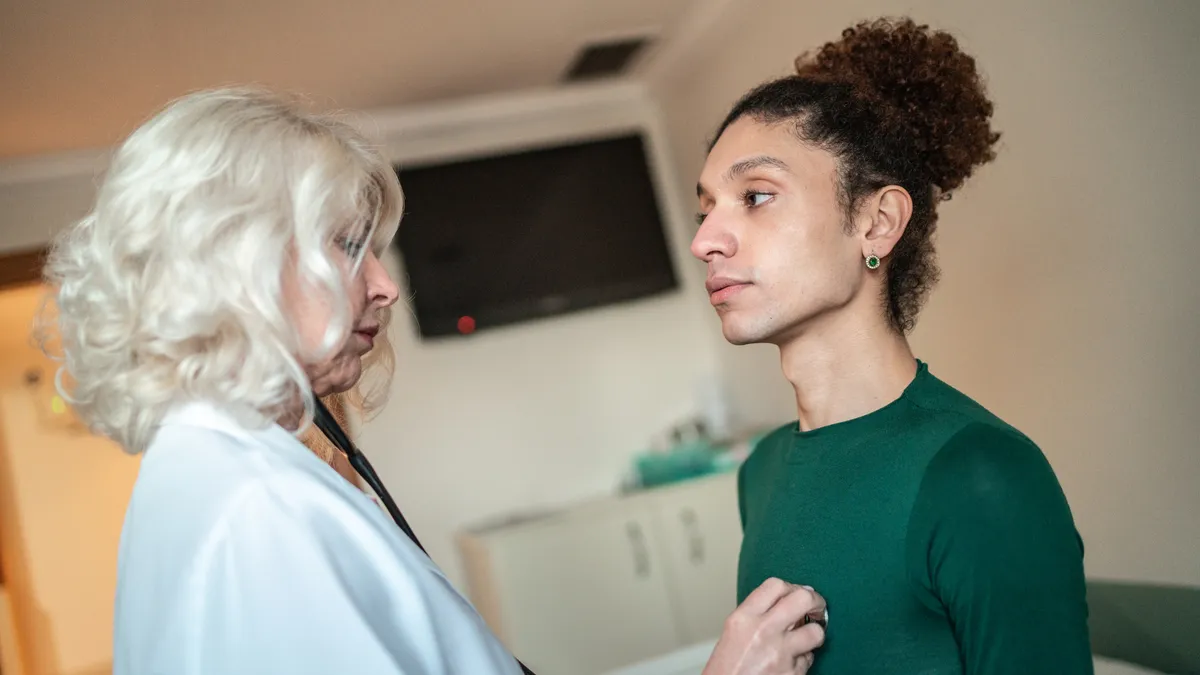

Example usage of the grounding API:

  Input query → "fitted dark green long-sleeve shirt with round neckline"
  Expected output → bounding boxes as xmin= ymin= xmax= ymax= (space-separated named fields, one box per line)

xmin=738 ymin=363 xmax=1093 ymax=675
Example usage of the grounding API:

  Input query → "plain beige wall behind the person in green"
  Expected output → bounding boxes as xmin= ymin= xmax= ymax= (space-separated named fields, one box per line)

xmin=653 ymin=0 xmax=1200 ymax=584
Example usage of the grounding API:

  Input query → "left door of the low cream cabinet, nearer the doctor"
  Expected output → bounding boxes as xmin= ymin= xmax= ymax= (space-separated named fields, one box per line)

xmin=487 ymin=503 xmax=680 ymax=675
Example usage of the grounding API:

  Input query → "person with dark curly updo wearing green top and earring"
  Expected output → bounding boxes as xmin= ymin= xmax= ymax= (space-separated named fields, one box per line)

xmin=691 ymin=19 xmax=1092 ymax=675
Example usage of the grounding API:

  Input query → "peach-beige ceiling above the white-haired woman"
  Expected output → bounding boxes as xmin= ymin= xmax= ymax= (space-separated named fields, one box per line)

xmin=0 ymin=0 xmax=703 ymax=157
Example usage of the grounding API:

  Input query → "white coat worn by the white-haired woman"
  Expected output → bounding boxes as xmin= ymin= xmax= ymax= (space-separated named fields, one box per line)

xmin=113 ymin=404 xmax=520 ymax=675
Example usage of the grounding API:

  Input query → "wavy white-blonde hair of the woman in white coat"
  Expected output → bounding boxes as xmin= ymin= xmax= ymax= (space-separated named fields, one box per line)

xmin=38 ymin=89 xmax=403 ymax=453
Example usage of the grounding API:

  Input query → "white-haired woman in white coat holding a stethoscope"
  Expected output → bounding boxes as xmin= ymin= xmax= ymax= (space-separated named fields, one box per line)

xmin=43 ymin=89 xmax=812 ymax=675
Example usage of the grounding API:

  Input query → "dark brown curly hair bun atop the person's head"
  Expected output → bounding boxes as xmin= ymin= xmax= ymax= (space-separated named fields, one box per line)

xmin=796 ymin=18 xmax=1000 ymax=195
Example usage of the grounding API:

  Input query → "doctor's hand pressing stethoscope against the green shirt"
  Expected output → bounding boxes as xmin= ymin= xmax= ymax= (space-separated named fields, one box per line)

xmin=703 ymin=571 xmax=826 ymax=675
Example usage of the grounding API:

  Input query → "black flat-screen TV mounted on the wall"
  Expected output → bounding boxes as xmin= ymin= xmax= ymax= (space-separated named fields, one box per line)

xmin=396 ymin=135 xmax=678 ymax=338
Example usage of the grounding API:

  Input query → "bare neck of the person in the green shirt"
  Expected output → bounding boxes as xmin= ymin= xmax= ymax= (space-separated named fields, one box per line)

xmin=779 ymin=303 xmax=917 ymax=431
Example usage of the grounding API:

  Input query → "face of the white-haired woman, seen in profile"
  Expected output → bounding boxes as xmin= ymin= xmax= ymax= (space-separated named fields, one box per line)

xmin=283 ymin=235 xmax=400 ymax=396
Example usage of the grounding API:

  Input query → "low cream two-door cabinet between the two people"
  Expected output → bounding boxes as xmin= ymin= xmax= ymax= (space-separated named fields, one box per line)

xmin=460 ymin=474 xmax=742 ymax=675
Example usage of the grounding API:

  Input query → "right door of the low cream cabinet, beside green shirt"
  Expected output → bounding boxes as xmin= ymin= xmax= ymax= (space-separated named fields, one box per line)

xmin=655 ymin=473 xmax=742 ymax=644
